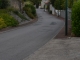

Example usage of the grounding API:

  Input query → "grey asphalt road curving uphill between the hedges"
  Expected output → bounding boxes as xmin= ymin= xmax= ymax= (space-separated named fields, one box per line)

xmin=0 ymin=9 xmax=64 ymax=60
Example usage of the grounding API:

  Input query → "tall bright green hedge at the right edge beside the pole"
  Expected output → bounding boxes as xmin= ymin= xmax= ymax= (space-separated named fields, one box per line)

xmin=71 ymin=0 xmax=80 ymax=36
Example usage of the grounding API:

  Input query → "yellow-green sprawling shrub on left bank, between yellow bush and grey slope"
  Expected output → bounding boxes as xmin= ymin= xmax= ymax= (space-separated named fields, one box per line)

xmin=0 ymin=9 xmax=18 ymax=27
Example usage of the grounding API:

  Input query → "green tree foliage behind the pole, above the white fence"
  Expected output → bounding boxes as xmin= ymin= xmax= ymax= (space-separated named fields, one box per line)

xmin=51 ymin=0 xmax=77 ymax=10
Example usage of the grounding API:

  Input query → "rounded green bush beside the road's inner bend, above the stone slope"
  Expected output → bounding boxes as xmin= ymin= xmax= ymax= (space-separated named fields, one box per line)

xmin=23 ymin=1 xmax=36 ymax=18
